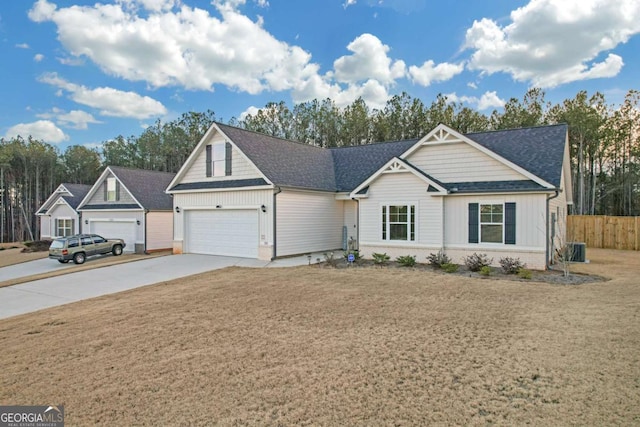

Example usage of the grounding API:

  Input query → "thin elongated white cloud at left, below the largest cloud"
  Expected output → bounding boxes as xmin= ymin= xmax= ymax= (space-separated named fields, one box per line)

xmin=39 ymin=73 xmax=167 ymax=119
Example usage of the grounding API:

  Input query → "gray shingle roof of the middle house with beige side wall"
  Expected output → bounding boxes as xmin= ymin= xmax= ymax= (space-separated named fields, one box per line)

xmin=108 ymin=166 xmax=175 ymax=211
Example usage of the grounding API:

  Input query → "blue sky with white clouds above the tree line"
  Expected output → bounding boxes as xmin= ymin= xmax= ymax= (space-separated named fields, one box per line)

xmin=0 ymin=0 xmax=640 ymax=151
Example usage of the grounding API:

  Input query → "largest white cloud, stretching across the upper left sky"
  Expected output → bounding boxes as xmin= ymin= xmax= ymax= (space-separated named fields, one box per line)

xmin=29 ymin=0 xmax=317 ymax=94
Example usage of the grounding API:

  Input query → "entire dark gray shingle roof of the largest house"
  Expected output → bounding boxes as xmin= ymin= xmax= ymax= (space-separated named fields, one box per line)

xmin=188 ymin=123 xmax=567 ymax=192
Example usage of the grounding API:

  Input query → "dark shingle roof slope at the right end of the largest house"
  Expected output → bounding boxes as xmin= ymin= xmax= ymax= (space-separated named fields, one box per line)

xmin=466 ymin=124 xmax=568 ymax=187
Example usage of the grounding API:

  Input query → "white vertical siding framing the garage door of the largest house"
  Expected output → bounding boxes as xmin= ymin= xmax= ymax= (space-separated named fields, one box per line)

xmin=173 ymin=189 xmax=273 ymax=251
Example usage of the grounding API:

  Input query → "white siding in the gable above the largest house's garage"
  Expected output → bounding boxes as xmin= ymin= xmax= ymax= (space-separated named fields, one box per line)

xmin=180 ymin=133 xmax=261 ymax=184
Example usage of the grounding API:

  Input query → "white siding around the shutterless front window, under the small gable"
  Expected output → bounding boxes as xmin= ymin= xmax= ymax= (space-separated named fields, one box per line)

xmin=360 ymin=172 xmax=443 ymax=247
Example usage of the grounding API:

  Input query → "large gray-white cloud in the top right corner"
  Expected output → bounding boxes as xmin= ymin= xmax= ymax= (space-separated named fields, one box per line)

xmin=465 ymin=0 xmax=640 ymax=87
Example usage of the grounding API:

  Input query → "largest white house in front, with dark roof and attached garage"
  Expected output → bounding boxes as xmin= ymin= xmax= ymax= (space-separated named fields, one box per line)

xmin=167 ymin=123 xmax=572 ymax=269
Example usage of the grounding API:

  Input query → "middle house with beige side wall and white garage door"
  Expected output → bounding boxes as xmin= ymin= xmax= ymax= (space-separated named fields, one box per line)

xmin=78 ymin=166 xmax=175 ymax=253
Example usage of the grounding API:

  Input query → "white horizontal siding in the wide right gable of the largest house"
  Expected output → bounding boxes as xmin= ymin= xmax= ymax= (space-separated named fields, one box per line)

xmin=407 ymin=142 xmax=528 ymax=182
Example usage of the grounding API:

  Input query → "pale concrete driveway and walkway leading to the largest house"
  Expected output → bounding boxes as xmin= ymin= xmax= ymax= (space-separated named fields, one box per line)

xmin=0 ymin=254 xmax=324 ymax=319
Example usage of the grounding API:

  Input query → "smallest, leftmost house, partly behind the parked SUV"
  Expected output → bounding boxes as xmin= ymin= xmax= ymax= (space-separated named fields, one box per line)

xmin=36 ymin=183 xmax=91 ymax=239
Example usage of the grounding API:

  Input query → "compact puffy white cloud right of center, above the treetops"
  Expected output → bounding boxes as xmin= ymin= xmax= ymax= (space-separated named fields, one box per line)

xmin=333 ymin=33 xmax=406 ymax=85
